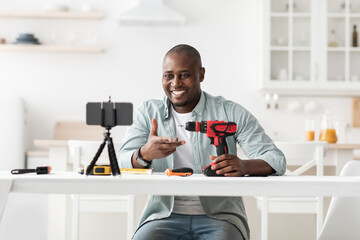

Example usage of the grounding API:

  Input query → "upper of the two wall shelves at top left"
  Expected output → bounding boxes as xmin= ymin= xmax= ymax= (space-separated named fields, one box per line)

xmin=0 ymin=10 xmax=104 ymax=20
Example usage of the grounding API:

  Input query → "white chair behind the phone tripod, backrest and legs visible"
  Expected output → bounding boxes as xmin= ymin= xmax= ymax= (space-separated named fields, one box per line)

xmin=68 ymin=140 xmax=135 ymax=240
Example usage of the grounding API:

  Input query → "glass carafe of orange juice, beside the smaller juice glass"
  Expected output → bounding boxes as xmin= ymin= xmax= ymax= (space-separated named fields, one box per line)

xmin=319 ymin=111 xmax=337 ymax=143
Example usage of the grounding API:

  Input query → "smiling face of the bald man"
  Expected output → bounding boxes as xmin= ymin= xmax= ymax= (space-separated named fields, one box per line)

xmin=162 ymin=52 xmax=205 ymax=113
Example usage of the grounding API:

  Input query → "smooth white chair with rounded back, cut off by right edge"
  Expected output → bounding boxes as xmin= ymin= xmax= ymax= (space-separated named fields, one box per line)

xmin=318 ymin=160 xmax=360 ymax=240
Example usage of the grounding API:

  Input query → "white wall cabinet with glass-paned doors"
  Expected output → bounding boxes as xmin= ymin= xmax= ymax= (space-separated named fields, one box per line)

xmin=260 ymin=0 xmax=360 ymax=96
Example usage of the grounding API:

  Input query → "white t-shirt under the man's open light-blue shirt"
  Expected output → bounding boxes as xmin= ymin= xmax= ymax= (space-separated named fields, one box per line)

xmin=171 ymin=107 xmax=205 ymax=215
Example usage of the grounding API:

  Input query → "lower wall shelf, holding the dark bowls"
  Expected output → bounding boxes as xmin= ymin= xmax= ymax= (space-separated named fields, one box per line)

xmin=0 ymin=44 xmax=104 ymax=53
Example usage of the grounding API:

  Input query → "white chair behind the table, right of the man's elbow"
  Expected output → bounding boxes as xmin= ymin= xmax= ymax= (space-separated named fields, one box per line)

xmin=257 ymin=142 xmax=327 ymax=240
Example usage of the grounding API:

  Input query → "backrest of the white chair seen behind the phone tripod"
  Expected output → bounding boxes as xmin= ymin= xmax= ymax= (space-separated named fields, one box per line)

xmin=68 ymin=140 xmax=121 ymax=171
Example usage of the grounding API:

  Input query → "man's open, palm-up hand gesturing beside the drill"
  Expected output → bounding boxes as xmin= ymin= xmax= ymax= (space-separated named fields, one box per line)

xmin=141 ymin=119 xmax=185 ymax=161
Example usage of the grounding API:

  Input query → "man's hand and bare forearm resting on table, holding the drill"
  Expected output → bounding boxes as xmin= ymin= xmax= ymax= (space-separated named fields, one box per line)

xmin=210 ymin=154 xmax=275 ymax=177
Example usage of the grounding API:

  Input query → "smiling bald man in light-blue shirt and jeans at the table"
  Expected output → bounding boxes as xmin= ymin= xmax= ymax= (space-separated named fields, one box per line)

xmin=119 ymin=45 xmax=286 ymax=240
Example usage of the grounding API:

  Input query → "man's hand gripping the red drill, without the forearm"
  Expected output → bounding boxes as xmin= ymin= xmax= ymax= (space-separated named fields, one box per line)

xmin=210 ymin=154 xmax=246 ymax=177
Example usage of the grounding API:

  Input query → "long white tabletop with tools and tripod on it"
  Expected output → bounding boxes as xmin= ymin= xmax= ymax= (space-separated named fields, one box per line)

xmin=0 ymin=172 xmax=360 ymax=198
